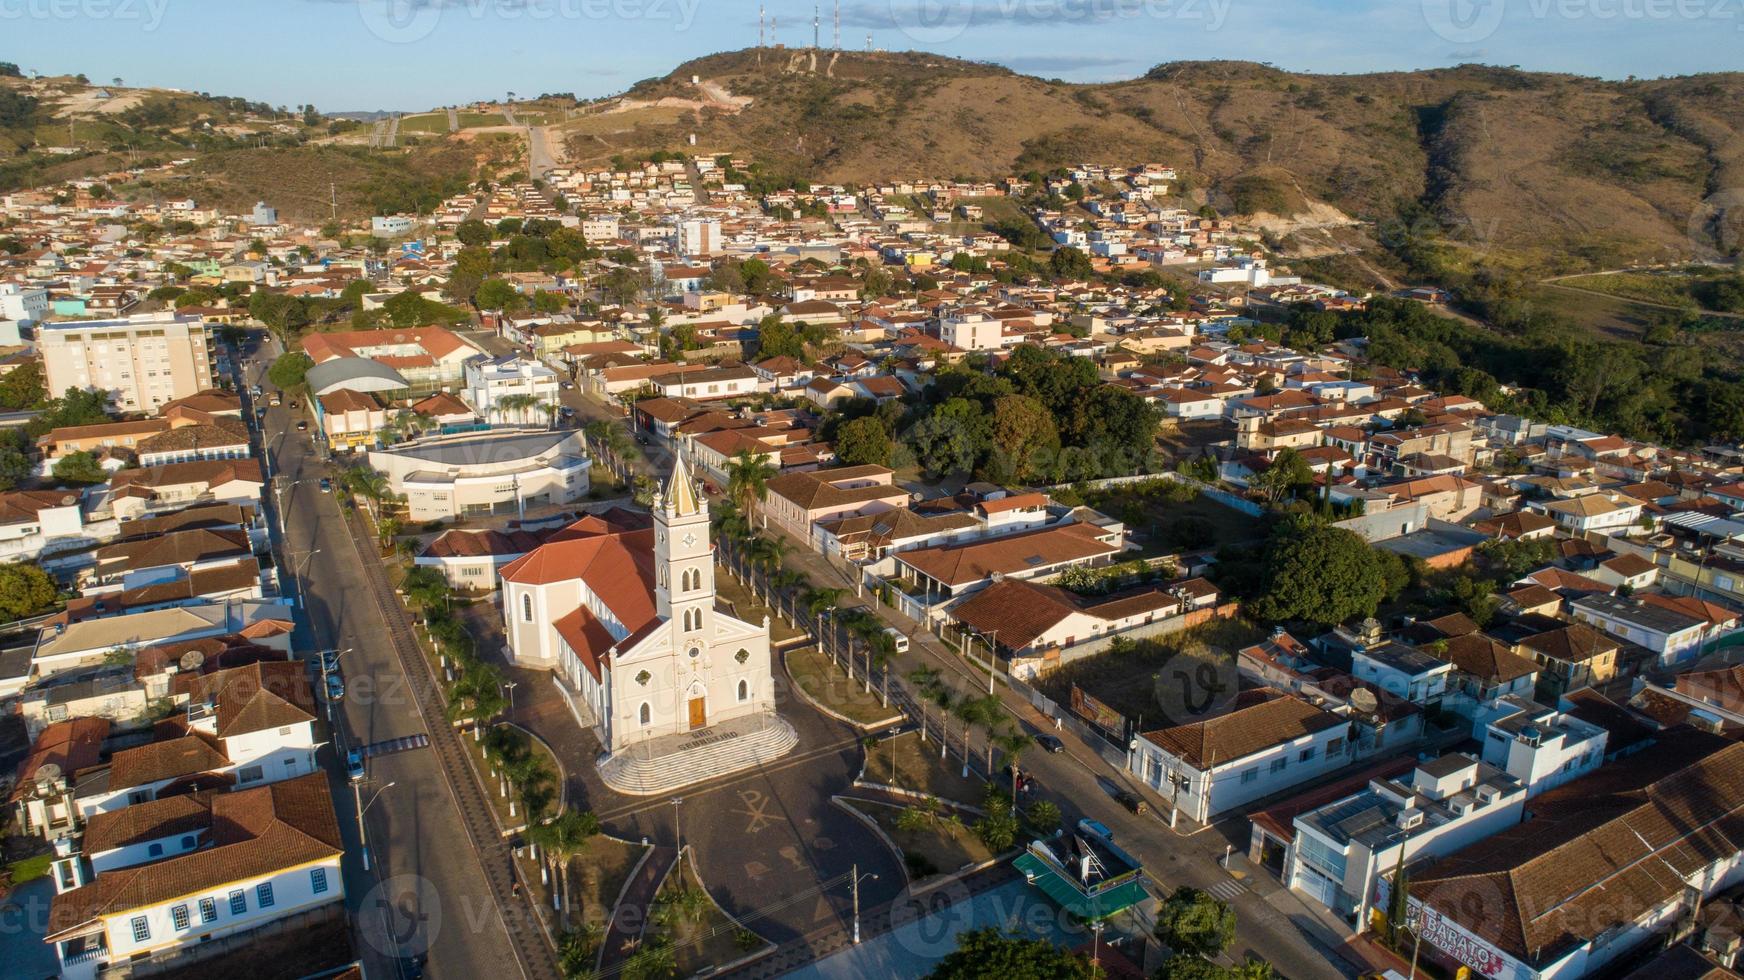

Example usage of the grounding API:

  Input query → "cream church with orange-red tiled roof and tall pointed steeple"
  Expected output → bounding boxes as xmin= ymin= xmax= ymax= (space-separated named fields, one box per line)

xmin=502 ymin=459 xmax=774 ymax=756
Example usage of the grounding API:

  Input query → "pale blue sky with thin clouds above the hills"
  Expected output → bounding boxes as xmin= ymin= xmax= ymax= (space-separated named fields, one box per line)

xmin=0 ymin=0 xmax=1744 ymax=112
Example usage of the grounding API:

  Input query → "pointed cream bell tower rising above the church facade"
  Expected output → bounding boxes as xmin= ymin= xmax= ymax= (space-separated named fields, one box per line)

xmin=654 ymin=457 xmax=715 ymax=650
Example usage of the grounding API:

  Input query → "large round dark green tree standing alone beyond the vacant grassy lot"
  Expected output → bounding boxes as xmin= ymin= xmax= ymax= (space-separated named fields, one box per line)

xmin=1249 ymin=520 xmax=1386 ymax=624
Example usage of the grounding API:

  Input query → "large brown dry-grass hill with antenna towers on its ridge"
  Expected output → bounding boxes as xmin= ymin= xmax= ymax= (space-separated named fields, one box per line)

xmin=569 ymin=51 xmax=1744 ymax=274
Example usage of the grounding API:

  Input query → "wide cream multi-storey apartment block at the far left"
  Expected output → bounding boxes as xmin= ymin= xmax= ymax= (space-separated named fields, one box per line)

xmin=37 ymin=312 xmax=213 ymax=412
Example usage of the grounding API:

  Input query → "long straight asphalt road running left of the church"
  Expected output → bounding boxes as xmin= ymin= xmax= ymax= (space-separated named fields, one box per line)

xmin=249 ymin=338 xmax=523 ymax=980
